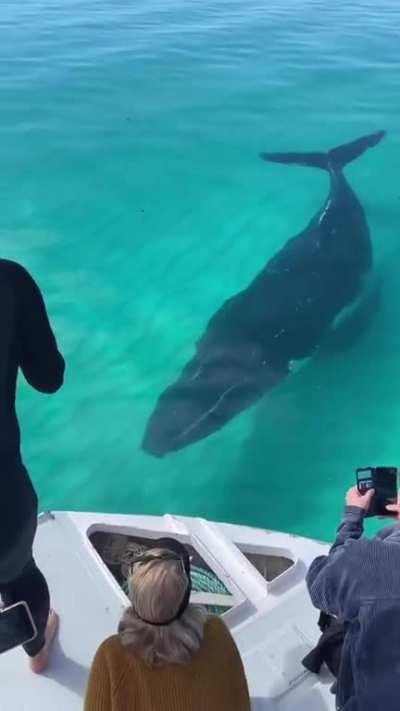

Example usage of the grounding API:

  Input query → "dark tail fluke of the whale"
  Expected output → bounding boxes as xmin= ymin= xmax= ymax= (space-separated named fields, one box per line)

xmin=260 ymin=131 xmax=386 ymax=170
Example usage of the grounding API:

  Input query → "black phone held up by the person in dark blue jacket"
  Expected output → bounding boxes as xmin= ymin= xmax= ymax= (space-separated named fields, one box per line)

xmin=356 ymin=467 xmax=398 ymax=516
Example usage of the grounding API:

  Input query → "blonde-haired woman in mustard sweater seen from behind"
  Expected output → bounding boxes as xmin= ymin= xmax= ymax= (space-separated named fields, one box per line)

xmin=85 ymin=538 xmax=250 ymax=711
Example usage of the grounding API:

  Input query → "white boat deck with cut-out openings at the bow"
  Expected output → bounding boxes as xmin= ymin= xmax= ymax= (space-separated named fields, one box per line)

xmin=0 ymin=513 xmax=334 ymax=711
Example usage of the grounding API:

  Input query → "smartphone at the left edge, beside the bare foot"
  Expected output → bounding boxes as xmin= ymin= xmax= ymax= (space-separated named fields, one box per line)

xmin=0 ymin=601 xmax=37 ymax=654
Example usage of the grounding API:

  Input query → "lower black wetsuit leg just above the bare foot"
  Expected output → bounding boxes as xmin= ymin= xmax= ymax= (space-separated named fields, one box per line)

xmin=0 ymin=558 xmax=50 ymax=657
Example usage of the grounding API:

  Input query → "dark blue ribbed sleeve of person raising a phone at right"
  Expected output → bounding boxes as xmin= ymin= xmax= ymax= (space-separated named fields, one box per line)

xmin=306 ymin=506 xmax=364 ymax=619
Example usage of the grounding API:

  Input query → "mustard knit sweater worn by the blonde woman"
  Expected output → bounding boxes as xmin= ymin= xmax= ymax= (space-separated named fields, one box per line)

xmin=85 ymin=617 xmax=250 ymax=711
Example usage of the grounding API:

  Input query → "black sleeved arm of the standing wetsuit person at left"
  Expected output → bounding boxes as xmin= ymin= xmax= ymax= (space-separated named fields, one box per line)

xmin=15 ymin=265 xmax=65 ymax=393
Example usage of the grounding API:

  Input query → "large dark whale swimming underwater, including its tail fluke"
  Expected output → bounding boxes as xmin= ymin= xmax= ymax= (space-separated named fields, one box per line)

xmin=142 ymin=131 xmax=385 ymax=457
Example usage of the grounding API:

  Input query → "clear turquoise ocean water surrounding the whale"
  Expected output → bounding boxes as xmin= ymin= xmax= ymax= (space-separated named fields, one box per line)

xmin=0 ymin=0 xmax=400 ymax=539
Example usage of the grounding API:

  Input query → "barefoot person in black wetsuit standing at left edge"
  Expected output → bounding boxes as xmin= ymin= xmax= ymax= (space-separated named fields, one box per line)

xmin=0 ymin=259 xmax=65 ymax=672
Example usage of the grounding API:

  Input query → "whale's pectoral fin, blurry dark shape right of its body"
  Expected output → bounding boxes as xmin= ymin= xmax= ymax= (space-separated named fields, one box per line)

xmin=318 ymin=278 xmax=382 ymax=357
